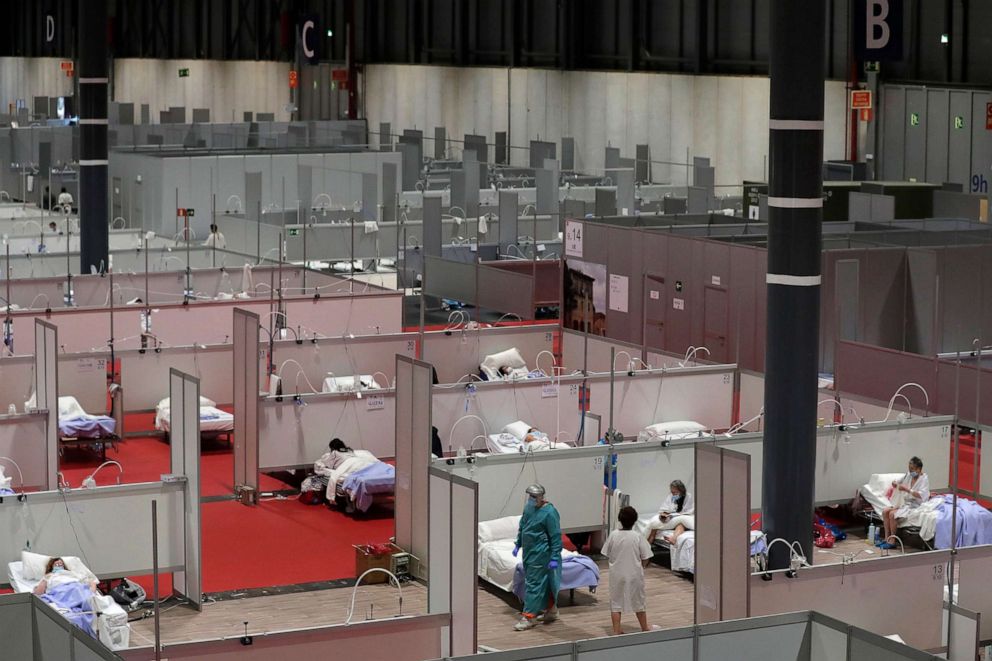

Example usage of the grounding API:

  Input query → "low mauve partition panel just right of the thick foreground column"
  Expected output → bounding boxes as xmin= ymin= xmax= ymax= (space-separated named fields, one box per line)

xmin=834 ymin=341 xmax=938 ymax=412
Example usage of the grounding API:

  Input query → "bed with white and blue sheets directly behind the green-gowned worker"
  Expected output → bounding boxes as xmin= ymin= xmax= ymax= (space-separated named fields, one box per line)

xmin=478 ymin=516 xmax=599 ymax=601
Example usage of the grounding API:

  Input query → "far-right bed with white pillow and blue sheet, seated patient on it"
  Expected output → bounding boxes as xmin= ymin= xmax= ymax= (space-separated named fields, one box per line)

xmin=858 ymin=473 xmax=992 ymax=550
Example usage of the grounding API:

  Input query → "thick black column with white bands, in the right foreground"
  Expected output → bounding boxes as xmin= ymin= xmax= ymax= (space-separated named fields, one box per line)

xmin=761 ymin=0 xmax=826 ymax=569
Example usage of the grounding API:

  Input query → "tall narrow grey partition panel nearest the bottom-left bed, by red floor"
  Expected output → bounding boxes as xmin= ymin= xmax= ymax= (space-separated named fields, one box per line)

xmin=169 ymin=368 xmax=203 ymax=610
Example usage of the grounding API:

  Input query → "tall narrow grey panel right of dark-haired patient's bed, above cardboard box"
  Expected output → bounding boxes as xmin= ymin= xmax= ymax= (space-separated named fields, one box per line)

xmin=394 ymin=355 xmax=432 ymax=578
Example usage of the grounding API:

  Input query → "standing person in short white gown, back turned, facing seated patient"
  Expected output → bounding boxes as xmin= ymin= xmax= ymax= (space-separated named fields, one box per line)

xmin=603 ymin=507 xmax=652 ymax=635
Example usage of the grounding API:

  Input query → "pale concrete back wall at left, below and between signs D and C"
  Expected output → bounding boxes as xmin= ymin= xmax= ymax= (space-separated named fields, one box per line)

xmin=0 ymin=57 xmax=290 ymax=124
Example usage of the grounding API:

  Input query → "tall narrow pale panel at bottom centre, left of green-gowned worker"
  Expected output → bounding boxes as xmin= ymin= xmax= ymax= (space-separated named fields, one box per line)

xmin=427 ymin=467 xmax=479 ymax=656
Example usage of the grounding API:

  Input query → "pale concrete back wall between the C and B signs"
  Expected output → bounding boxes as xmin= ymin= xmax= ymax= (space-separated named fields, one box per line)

xmin=365 ymin=65 xmax=846 ymax=192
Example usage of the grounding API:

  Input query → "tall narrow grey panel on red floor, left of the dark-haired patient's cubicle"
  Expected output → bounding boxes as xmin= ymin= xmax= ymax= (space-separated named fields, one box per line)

xmin=232 ymin=308 xmax=259 ymax=494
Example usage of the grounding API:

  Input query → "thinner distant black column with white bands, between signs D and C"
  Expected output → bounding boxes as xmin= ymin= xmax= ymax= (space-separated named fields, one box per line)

xmin=76 ymin=0 xmax=110 ymax=273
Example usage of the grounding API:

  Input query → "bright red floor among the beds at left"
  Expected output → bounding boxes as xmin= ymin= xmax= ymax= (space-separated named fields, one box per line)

xmin=61 ymin=416 xmax=394 ymax=594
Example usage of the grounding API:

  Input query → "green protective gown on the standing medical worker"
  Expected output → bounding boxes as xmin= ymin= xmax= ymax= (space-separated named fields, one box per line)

xmin=517 ymin=503 xmax=561 ymax=617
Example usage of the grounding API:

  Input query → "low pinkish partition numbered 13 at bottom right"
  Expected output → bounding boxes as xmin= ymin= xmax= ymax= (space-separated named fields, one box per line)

xmin=748 ymin=547 xmax=951 ymax=648
